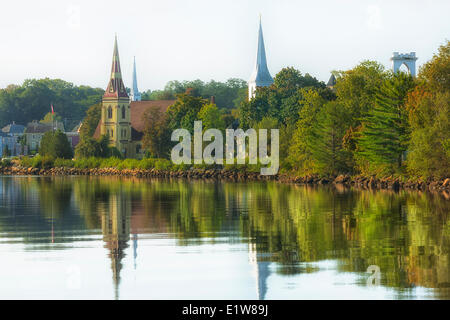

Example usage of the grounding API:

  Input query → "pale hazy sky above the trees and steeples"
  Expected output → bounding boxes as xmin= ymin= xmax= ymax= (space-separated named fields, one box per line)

xmin=0 ymin=0 xmax=450 ymax=91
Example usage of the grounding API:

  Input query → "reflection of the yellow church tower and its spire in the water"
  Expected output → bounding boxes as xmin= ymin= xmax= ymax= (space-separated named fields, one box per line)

xmin=102 ymin=195 xmax=131 ymax=299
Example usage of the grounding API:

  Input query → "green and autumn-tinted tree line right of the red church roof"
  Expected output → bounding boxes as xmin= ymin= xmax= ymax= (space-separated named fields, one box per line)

xmin=139 ymin=41 xmax=450 ymax=179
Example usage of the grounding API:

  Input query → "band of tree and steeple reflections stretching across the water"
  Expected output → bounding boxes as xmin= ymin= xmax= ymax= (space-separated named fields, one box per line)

xmin=0 ymin=177 xmax=450 ymax=298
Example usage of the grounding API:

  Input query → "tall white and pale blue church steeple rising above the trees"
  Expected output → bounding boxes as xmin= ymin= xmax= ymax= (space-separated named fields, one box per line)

xmin=248 ymin=18 xmax=273 ymax=100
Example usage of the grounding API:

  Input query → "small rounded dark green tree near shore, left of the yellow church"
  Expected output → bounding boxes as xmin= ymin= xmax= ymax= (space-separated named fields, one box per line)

xmin=39 ymin=130 xmax=73 ymax=159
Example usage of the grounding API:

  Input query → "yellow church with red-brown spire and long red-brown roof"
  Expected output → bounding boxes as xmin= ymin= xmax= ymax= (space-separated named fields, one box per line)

xmin=94 ymin=37 xmax=175 ymax=158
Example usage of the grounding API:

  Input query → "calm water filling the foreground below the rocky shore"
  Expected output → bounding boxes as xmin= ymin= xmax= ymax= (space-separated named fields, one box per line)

xmin=0 ymin=177 xmax=450 ymax=299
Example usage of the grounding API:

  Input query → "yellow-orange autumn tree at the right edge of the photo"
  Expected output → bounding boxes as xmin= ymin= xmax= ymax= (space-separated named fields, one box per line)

xmin=406 ymin=41 xmax=450 ymax=178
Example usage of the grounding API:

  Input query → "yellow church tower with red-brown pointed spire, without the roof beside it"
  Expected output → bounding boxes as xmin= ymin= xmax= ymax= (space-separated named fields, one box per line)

xmin=100 ymin=36 xmax=133 ymax=157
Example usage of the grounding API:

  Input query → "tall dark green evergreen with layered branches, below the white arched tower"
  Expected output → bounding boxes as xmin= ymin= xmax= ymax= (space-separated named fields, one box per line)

xmin=357 ymin=72 xmax=414 ymax=171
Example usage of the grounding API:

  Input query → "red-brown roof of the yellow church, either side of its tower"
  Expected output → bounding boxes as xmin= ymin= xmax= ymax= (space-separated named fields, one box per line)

xmin=93 ymin=100 xmax=175 ymax=140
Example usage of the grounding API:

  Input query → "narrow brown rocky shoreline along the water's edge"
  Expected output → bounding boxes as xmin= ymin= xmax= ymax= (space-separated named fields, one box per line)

xmin=0 ymin=166 xmax=450 ymax=193
